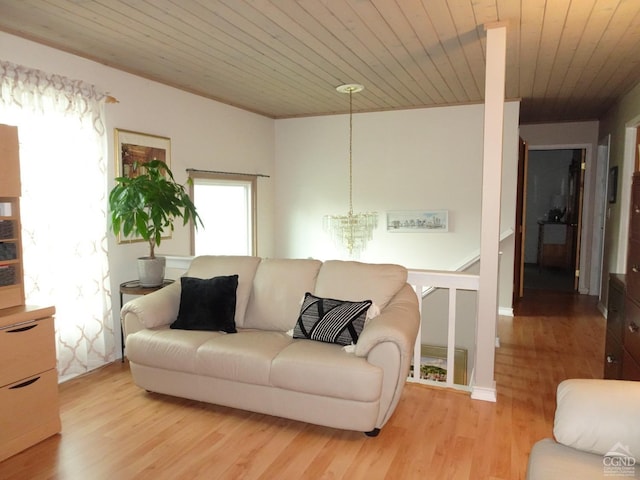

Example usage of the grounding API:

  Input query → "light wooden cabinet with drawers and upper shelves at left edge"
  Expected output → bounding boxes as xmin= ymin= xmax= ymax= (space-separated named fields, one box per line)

xmin=0 ymin=125 xmax=61 ymax=461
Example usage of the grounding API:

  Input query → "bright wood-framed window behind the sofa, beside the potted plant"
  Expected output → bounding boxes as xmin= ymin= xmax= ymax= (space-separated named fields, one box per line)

xmin=189 ymin=171 xmax=256 ymax=255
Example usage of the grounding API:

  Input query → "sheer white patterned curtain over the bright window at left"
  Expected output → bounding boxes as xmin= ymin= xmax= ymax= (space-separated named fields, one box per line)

xmin=0 ymin=61 xmax=115 ymax=380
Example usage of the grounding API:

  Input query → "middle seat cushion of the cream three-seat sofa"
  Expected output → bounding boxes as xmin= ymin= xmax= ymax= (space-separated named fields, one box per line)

xmin=194 ymin=330 xmax=293 ymax=385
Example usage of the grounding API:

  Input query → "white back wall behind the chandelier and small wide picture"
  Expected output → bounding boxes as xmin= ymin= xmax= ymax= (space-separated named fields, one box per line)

xmin=275 ymin=102 xmax=519 ymax=308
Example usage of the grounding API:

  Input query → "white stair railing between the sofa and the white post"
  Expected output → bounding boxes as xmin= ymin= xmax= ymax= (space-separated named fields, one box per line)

xmin=407 ymin=270 xmax=480 ymax=390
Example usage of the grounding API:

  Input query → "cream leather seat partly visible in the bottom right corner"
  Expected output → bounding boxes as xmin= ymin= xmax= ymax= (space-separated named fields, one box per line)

xmin=527 ymin=379 xmax=640 ymax=480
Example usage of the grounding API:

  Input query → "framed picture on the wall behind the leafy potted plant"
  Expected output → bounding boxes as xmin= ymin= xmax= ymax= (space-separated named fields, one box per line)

xmin=114 ymin=128 xmax=171 ymax=243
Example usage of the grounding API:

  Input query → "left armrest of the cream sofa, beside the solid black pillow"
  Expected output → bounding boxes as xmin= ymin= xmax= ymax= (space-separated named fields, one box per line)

xmin=120 ymin=282 xmax=181 ymax=335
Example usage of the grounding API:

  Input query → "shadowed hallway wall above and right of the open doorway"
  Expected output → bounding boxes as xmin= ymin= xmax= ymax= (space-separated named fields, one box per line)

xmin=520 ymin=121 xmax=601 ymax=295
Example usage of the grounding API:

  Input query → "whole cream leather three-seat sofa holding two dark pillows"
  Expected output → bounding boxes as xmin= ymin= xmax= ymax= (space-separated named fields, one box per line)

xmin=121 ymin=256 xmax=420 ymax=435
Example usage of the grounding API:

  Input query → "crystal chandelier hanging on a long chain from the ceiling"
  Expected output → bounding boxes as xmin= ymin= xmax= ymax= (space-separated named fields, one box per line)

xmin=323 ymin=83 xmax=378 ymax=258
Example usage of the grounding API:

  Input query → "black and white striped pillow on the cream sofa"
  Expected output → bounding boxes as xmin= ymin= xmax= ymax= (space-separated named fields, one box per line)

xmin=293 ymin=292 xmax=372 ymax=345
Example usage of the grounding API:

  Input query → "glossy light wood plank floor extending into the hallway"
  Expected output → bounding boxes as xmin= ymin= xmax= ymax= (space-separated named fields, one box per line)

xmin=0 ymin=294 xmax=605 ymax=480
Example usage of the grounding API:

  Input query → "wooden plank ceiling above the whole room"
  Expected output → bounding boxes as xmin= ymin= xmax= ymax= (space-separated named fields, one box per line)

xmin=0 ymin=0 xmax=640 ymax=123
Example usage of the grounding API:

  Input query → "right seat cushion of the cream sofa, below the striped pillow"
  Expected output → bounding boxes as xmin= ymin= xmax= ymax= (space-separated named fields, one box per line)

xmin=271 ymin=340 xmax=382 ymax=402
